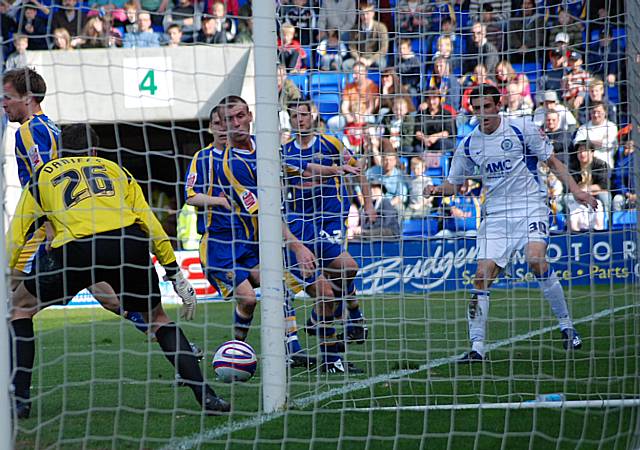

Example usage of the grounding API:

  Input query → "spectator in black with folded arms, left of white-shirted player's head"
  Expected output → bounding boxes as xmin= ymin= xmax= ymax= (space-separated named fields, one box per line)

xmin=416 ymin=89 xmax=456 ymax=152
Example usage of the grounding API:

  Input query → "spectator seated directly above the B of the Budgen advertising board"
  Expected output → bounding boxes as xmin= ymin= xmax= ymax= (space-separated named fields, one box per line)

xmin=355 ymin=179 xmax=400 ymax=239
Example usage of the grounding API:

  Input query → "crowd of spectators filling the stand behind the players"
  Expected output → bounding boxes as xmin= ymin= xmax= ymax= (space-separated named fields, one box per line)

xmin=0 ymin=0 xmax=636 ymax=236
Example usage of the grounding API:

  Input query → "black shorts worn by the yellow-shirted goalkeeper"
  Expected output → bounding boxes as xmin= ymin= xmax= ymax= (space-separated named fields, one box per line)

xmin=24 ymin=225 xmax=161 ymax=311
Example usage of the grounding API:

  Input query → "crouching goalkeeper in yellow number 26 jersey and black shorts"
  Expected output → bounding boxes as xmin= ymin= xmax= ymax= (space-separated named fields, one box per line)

xmin=7 ymin=124 xmax=230 ymax=417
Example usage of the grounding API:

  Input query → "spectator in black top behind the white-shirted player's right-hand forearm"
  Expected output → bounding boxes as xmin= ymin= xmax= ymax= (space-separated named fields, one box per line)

xmin=566 ymin=141 xmax=611 ymax=231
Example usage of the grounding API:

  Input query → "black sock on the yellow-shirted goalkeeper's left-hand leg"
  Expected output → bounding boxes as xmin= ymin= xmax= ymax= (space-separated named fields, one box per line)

xmin=9 ymin=319 xmax=36 ymax=400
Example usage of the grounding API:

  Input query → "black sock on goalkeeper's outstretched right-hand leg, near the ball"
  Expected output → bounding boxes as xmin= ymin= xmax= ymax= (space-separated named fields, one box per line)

xmin=156 ymin=322 xmax=216 ymax=403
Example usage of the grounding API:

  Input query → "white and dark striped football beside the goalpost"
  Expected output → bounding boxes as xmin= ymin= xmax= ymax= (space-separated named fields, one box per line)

xmin=211 ymin=341 xmax=258 ymax=383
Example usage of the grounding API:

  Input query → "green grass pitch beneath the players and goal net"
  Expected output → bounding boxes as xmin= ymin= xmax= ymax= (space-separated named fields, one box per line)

xmin=16 ymin=285 xmax=640 ymax=450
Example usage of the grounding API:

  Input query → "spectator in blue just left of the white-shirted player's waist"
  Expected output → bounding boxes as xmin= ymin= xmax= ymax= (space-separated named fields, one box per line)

xmin=442 ymin=179 xmax=482 ymax=233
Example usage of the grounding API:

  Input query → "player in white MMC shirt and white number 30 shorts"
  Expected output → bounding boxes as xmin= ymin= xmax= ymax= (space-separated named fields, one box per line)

xmin=429 ymin=85 xmax=597 ymax=362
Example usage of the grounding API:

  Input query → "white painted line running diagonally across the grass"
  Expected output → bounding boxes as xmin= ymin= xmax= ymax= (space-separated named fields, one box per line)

xmin=162 ymin=304 xmax=640 ymax=450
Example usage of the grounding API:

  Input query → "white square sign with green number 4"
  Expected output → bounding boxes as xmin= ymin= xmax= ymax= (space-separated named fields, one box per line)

xmin=122 ymin=57 xmax=173 ymax=108
